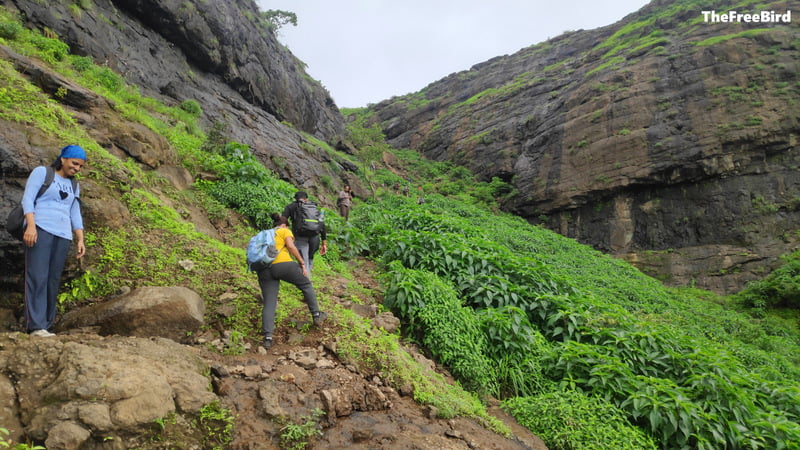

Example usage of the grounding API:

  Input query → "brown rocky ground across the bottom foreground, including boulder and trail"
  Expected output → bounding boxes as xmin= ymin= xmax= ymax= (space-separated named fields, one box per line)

xmin=0 ymin=255 xmax=546 ymax=450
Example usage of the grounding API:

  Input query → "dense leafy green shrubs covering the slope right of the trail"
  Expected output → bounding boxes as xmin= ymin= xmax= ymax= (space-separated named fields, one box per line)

xmin=356 ymin=197 xmax=800 ymax=449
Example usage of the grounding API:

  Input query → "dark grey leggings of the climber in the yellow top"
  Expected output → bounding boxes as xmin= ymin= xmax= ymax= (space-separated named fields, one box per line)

xmin=258 ymin=261 xmax=319 ymax=337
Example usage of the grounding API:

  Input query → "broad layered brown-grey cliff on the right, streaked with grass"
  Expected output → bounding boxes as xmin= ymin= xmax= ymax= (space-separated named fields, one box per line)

xmin=372 ymin=1 xmax=800 ymax=293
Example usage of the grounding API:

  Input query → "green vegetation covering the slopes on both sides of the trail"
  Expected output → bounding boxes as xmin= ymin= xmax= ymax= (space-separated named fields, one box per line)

xmin=0 ymin=7 xmax=800 ymax=449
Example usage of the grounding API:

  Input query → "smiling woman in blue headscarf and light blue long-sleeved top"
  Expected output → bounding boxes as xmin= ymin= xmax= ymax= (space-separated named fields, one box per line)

xmin=22 ymin=145 xmax=86 ymax=337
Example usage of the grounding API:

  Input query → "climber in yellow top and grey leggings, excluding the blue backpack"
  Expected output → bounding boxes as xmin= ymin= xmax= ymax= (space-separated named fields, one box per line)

xmin=258 ymin=213 xmax=328 ymax=349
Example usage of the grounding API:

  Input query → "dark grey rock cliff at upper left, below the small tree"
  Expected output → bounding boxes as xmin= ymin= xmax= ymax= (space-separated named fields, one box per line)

xmin=4 ymin=0 xmax=343 ymax=139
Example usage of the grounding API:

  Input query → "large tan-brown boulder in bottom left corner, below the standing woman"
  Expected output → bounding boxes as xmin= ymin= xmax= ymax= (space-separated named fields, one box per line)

xmin=0 ymin=333 xmax=217 ymax=449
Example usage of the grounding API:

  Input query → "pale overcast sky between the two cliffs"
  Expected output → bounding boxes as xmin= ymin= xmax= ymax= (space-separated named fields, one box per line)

xmin=256 ymin=0 xmax=648 ymax=108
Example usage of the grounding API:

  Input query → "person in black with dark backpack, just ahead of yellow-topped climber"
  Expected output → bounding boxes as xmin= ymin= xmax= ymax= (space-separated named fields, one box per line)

xmin=281 ymin=191 xmax=328 ymax=278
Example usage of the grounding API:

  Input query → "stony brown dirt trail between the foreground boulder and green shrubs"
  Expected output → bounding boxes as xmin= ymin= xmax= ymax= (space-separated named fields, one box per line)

xmin=207 ymin=260 xmax=546 ymax=450
